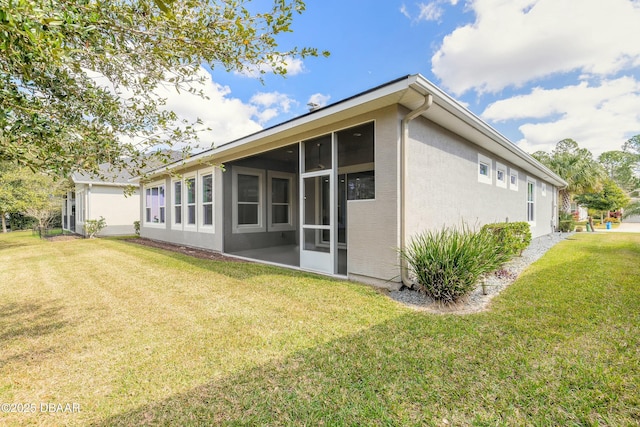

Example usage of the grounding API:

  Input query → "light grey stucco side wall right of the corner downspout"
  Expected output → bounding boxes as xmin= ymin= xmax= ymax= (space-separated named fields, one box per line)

xmin=406 ymin=117 xmax=555 ymax=237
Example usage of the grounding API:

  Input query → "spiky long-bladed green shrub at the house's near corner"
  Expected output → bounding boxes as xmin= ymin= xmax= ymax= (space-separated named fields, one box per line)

xmin=400 ymin=226 xmax=510 ymax=303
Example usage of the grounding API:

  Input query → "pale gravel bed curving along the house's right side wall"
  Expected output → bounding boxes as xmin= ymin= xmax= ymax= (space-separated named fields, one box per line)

xmin=389 ymin=233 xmax=573 ymax=314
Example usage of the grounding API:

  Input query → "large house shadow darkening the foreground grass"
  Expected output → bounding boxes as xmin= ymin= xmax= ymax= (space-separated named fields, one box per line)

xmin=94 ymin=294 xmax=633 ymax=427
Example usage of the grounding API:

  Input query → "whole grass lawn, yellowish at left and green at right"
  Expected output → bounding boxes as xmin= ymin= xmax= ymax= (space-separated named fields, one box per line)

xmin=0 ymin=232 xmax=640 ymax=426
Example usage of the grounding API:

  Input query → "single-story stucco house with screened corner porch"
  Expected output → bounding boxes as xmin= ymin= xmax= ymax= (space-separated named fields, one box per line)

xmin=135 ymin=75 xmax=566 ymax=288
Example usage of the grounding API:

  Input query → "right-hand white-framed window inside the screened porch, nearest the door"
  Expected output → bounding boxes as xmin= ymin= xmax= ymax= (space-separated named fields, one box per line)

xmin=268 ymin=171 xmax=295 ymax=231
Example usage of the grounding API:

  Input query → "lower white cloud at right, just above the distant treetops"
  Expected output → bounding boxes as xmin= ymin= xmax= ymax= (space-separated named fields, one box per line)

xmin=481 ymin=77 xmax=640 ymax=156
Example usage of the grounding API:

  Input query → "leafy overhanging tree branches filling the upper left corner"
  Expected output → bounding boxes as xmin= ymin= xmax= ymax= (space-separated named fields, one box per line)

xmin=0 ymin=0 xmax=327 ymax=176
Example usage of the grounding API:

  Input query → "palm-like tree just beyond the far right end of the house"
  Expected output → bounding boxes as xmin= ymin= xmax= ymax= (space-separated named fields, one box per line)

xmin=533 ymin=139 xmax=606 ymax=213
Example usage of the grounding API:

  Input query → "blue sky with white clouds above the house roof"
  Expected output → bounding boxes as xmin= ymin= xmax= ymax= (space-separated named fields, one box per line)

xmin=159 ymin=0 xmax=640 ymax=156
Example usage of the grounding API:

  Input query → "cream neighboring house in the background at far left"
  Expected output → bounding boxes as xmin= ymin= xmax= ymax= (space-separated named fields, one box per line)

xmin=62 ymin=165 xmax=140 ymax=236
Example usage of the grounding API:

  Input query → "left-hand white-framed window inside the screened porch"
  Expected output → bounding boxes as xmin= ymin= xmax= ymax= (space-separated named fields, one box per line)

xmin=233 ymin=167 xmax=265 ymax=233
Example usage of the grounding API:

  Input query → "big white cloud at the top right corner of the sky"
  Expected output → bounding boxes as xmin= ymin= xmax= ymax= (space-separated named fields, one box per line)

xmin=432 ymin=0 xmax=640 ymax=95
